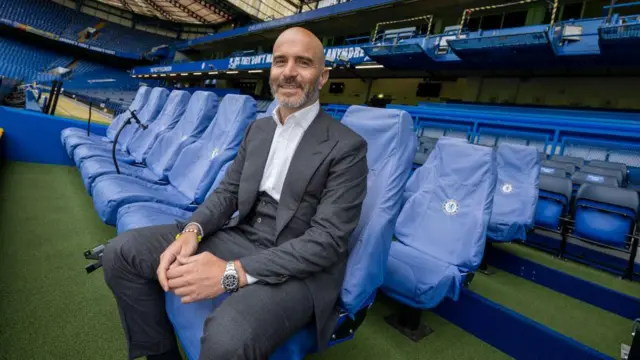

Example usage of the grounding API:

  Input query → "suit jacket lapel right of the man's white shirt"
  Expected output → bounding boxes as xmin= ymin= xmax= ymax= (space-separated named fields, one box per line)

xmin=276 ymin=110 xmax=335 ymax=237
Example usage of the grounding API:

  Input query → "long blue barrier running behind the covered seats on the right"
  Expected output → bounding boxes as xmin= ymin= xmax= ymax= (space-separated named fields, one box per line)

xmin=387 ymin=105 xmax=640 ymax=186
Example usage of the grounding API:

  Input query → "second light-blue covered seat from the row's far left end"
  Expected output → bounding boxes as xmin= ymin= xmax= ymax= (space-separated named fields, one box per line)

xmin=73 ymin=88 xmax=169 ymax=166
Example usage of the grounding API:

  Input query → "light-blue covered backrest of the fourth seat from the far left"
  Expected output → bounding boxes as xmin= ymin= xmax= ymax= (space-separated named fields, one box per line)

xmin=145 ymin=91 xmax=218 ymax=178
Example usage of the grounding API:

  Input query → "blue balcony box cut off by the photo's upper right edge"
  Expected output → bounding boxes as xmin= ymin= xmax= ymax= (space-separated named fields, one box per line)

xmin=598 ymin=15 xmax=640 ymax=61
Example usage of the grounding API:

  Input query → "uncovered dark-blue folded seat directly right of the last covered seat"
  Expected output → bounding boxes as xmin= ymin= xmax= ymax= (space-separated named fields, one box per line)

xmin=535 ymin=174 xmax=572 ymax=230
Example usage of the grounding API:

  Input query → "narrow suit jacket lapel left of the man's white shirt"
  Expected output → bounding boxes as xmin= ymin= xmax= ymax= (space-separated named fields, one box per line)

xmin=238 ymin=119 xmax=276 ymax=219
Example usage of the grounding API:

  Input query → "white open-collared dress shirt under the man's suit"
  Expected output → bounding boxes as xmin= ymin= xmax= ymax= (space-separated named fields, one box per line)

xmin=259 ymin=101 xmax=320 ymax=201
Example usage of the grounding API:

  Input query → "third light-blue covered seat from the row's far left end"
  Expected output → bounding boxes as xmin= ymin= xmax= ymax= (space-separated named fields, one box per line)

xmin=78 ymin=90 xmax=194 ymax=194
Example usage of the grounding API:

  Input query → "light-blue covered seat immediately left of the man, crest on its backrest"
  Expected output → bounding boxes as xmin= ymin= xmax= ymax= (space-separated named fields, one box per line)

xmin=92 ymin=94 xmax=256 ymax=225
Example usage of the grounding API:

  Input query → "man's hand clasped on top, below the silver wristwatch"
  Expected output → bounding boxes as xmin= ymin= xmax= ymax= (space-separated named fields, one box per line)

xmin=167 ymin=251 xmax=227 ymax=304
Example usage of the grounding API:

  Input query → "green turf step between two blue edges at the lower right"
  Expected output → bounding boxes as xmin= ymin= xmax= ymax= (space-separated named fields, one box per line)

xmin=470 ymin=256 xmax=631 ymax=358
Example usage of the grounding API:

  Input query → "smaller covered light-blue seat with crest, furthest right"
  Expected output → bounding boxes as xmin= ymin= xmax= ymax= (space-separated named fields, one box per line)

xmin=487 ymin=144 xmax=540 ymax=242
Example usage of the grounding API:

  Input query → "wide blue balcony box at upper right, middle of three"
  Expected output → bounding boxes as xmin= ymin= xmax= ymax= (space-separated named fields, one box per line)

xmin=448 ymin=25 xmax=555 ymax=66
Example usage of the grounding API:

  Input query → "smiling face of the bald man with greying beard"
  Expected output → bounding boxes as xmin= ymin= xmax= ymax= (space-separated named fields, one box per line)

xmin=269 ymin=35 xmax=326 ymax=109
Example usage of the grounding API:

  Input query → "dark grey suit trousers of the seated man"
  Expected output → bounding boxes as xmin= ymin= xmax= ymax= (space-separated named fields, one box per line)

xmin=102 ymin=225 xmax=313 ymax=360
